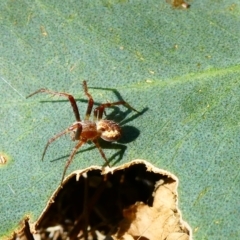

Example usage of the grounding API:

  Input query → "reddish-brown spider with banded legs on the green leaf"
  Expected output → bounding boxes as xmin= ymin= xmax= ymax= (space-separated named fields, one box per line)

xmin=26 ymin=81 xmax=138 ymax=184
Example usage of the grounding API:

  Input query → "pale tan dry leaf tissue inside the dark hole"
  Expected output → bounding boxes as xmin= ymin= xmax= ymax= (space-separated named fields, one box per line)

xmin=114 ymin=173 xmax=190 ymax=240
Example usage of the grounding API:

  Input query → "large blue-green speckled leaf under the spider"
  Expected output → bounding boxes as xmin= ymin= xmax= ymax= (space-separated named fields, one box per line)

xmin=0 ymin=0 xmax=240 ymax=239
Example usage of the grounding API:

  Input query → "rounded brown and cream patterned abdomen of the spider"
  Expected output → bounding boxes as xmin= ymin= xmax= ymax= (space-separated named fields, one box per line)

xmin=97 ymin=120 xmax=122 ymax=142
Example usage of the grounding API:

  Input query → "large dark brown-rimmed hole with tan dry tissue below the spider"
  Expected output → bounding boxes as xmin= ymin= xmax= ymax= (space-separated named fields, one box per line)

xmin=29 ymin=160 xmax=192 ymax=240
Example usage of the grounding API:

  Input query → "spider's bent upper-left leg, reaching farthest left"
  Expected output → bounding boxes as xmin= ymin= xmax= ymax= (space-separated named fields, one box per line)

xmin=26 ymin=88 xmax=81 ymax=122
